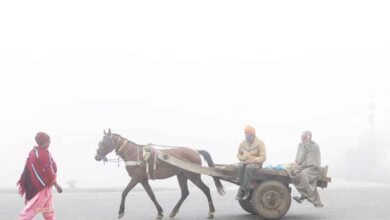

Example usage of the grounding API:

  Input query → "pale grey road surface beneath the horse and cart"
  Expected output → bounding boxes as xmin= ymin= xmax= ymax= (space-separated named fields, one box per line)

xmin=0 ymin=185 xmax=390 ymax=220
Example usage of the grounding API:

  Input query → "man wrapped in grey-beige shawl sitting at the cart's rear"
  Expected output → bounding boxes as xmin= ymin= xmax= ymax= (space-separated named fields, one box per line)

xmin=289 ymin=131 xmax=324 ymax=208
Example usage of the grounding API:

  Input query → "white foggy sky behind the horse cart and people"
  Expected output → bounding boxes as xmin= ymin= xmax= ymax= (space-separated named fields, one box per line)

xmin=0 ymin=0 xmax=390 ymax=188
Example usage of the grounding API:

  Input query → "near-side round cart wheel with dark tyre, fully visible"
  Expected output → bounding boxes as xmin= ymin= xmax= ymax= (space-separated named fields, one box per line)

xmin=252 ymin=180 xmax=291 ymax=219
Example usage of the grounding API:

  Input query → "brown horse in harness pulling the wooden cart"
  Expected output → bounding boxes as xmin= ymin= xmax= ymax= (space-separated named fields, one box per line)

xmin=95 ymin=129 xmax=224 ymax=219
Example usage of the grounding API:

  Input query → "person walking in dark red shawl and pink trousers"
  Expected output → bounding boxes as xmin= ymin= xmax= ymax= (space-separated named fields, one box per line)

xmin=18 ymin=132 xmax=62 ymax=220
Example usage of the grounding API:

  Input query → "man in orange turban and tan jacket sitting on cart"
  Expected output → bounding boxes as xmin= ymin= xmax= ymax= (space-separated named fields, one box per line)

xmin=236 ymin=126 xmax=266 ymax=200
